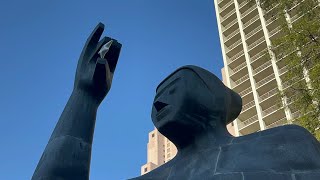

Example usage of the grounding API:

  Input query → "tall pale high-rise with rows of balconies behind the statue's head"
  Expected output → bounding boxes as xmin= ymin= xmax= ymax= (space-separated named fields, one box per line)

xmin=214 ymin=0 xmax=299 ymax=136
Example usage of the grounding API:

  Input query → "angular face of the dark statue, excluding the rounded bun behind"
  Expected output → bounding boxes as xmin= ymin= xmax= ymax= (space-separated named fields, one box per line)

xmin=151 ymin=69 xmax=213 ymax=134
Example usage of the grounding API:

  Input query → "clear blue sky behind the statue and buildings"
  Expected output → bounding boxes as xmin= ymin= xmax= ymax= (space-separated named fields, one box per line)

xmin=0 ymin=0 xmax=223 ymax=180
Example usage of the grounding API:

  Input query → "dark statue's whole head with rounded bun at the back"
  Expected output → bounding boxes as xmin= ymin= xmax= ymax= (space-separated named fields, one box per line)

xmin=151 ymin=66 xmax=242 ymax=147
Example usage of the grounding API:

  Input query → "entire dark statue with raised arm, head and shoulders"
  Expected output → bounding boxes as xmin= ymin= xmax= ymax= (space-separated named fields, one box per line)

xmin=32 ymin=23 xmax=320 ymax=180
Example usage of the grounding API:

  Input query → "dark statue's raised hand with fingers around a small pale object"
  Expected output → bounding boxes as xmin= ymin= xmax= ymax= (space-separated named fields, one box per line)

xmin=74 ymin=23 xmax=121 ymax=103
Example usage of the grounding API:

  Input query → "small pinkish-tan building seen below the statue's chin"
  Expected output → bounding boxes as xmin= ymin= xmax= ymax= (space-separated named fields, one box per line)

xmin=141 ymin=129 xmax=177 ymax=175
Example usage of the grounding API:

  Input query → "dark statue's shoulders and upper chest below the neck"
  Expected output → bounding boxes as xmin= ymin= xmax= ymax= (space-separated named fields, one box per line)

xmin=131 ymin=125 xmax=320 ymax=180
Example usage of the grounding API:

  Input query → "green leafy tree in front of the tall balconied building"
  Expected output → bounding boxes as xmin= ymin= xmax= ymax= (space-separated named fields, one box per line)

xmin=249 ymin=0 xmax=320 ymax=140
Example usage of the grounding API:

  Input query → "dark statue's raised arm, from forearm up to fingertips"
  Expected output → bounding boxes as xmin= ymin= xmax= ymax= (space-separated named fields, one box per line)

xmin=32 ymin=23 xmax=121 ymax=180
